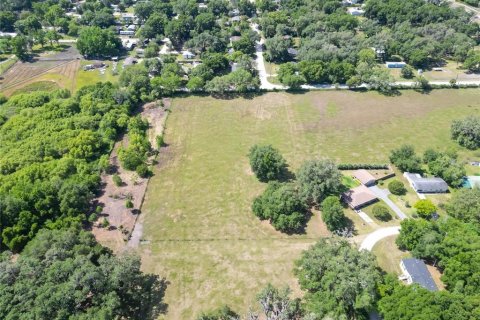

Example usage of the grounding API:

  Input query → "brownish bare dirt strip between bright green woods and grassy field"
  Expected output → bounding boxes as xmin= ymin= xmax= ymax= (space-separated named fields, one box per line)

xmin=92 ymin=99 xmax=170 ymax=251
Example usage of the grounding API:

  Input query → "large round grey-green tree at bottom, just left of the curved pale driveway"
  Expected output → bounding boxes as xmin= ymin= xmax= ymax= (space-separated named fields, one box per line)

xmin=295 ymin=238 xmax=381 ymax=319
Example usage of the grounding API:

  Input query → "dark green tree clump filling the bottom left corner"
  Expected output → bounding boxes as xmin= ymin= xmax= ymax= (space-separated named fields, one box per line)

xmin=0 ymin=229 xmax=166 ymax=320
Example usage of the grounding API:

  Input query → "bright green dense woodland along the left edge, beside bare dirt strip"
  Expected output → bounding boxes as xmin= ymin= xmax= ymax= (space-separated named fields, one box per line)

xmin=0 ymin=83 xmax=132 ymax=251
